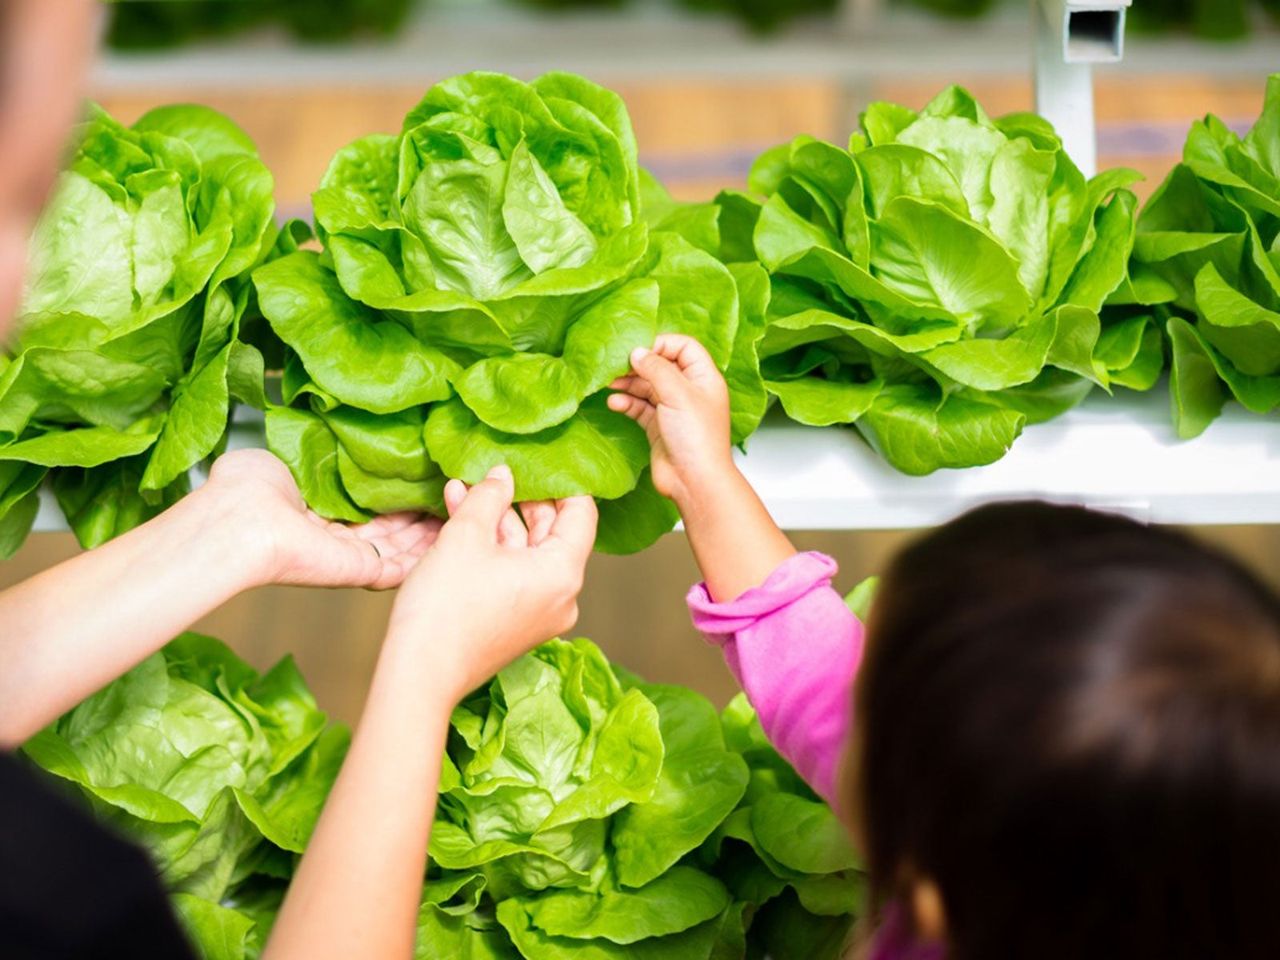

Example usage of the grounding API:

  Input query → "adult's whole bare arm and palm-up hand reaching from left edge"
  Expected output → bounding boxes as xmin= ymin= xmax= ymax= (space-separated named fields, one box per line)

xmin=0 ymin=451 xmax=439 ymax=748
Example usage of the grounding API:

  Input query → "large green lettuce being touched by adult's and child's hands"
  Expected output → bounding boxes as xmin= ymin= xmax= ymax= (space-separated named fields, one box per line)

xmin=255 ymin=73 xmax=740 ymax=552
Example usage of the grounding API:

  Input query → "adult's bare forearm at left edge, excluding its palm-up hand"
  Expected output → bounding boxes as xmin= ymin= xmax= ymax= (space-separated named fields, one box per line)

xmin=0 ymin=483 xmax=260 ymax=748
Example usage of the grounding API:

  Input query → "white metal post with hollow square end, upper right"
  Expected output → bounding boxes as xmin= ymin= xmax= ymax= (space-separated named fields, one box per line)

xmin=1032 ymin=0 xmax=1132 ymax=177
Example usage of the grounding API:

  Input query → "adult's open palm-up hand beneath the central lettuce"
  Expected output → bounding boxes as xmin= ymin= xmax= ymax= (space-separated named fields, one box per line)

xmin=196 ymin=449 xmax=442 ymax=590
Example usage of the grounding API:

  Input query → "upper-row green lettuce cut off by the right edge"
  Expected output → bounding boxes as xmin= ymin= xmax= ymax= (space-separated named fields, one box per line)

xmin=1117 ymin=74 xmax=1280 ymax=438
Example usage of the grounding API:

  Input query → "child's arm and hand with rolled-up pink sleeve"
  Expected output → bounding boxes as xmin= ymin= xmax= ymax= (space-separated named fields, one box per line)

xmin=609 ymin=335 xmax=863 ymax=801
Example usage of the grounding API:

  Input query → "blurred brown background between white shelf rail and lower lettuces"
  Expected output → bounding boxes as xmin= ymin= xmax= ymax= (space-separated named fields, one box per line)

xmin=10 ymin=527 xmax=1280 ymax=722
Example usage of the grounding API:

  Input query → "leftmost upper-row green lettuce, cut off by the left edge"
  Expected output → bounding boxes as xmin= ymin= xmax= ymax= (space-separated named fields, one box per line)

xmin=0 ymin=106 xmax=276 ymax=553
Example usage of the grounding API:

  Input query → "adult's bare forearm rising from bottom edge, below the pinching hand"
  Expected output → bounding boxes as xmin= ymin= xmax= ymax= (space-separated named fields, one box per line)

xmin=264 ymin=621 xmax=461 ymax=960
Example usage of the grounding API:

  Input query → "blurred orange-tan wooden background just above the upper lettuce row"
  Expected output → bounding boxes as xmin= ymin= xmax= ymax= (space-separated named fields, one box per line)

xmin=92 ymin=73 xmax=1265 ymax=214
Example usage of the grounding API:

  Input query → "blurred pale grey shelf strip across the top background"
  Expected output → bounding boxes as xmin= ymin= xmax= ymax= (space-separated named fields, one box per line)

xmin=93 ymin=4 xmax=1277 ymax=95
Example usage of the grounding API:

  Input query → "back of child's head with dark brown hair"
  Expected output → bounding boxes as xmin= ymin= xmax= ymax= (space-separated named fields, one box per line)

xmin=852 ymin=503 xmax=1280 ymax=960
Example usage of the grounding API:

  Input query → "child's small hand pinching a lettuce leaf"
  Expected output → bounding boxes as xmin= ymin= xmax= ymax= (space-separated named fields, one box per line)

xmin=609 ymin=333 xmax=733 ymax=507
